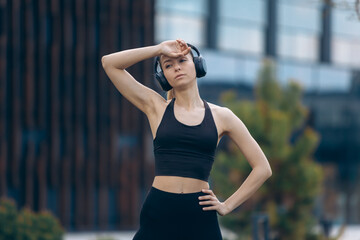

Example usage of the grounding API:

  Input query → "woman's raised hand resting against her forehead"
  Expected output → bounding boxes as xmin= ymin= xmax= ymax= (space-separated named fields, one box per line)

xmin=160 ymin=39 xmax=191 ymax=58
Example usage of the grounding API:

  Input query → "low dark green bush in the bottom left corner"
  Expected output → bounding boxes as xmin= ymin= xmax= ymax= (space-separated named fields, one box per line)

xmin=0 ymin=199 xmax=64 ymax=240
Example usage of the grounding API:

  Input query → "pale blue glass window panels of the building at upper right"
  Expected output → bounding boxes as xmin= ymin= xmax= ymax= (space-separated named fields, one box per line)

xmin=155 ymin=0 xmax=360 ymax=92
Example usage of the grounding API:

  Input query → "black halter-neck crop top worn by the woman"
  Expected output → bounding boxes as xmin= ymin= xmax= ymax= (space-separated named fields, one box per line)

xmin=153 ymin=98 xmax=218 ymax=181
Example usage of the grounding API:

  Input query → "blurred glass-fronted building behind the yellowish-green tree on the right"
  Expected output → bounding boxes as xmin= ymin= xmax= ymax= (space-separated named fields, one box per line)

xmin=155 ymin=0 xmax=360 ymax=224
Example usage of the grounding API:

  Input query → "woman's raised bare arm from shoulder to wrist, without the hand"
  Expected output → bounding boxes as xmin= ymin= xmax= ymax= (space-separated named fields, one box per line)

xmin=101 ymin=44 xmax=166 ymax=114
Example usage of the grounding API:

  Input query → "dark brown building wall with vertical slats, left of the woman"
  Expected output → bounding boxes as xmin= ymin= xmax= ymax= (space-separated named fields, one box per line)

xmin=0 ymin=0 xmax=154 ymax=230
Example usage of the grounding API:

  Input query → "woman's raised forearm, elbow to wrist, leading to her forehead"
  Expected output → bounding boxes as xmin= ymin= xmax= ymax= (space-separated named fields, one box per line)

xmin=102 ymin=45 xmax=161 ymax=69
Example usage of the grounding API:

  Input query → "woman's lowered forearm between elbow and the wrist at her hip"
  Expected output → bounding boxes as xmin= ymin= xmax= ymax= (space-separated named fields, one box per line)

xmin=224 ymin=167 xmax=270 ymax=213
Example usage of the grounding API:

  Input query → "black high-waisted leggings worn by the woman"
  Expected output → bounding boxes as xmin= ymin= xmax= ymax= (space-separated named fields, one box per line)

xmin=133 ymin=187 xmax=222 ymax=240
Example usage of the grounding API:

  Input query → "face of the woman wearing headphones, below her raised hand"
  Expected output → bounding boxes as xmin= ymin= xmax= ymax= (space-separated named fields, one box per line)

xmin=160 ymin=53 xmax=196 ymax=88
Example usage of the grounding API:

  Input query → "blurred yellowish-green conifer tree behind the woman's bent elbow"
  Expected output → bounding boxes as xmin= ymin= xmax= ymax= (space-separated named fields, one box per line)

xmin=211 ymin=60 xmax=323 ymax=240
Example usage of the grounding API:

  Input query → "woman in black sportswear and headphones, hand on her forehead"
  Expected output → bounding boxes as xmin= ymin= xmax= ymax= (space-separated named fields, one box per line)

xmin=102 ymin=39 xmax=272 ymax=240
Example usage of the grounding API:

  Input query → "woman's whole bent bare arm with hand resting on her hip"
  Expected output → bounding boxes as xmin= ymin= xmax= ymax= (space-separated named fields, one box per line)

xmin=198 ymin=108 xmax=272 ymax=216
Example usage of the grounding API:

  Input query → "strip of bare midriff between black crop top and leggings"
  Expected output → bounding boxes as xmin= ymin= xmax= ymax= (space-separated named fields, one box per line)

xmin=152 ymin=176 xmax=210 ymax=193
